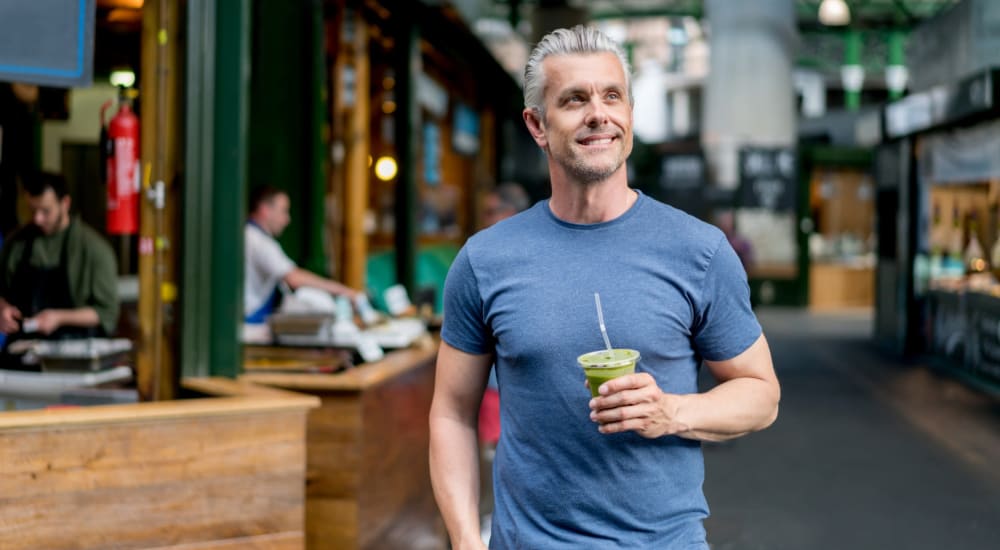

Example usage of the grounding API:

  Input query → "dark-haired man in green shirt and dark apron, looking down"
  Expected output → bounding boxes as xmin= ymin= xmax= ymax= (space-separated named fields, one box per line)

xmin=0 ymin=173 xmax=118 ymax=359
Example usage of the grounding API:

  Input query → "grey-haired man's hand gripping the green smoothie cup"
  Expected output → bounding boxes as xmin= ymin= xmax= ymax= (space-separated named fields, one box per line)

xmin=590 ymin=373 xmax=688 ymax=439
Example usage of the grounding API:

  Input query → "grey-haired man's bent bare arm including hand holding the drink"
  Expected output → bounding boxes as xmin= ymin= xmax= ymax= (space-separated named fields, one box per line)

xmin=590 ymin=334 xmax=781 ymax=441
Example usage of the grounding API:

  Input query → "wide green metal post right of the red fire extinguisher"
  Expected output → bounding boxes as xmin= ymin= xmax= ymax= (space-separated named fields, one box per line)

xmin=179 ymin=0 xmax=250 ymax=377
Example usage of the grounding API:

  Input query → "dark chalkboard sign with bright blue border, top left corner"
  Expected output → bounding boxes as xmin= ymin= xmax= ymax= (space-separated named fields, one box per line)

xmin=0 ymin=0 xmax=94 ymax=88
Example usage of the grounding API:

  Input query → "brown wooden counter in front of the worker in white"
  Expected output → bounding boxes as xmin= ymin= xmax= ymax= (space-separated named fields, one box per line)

xmin=241 ymin=343 xmax=447 ymax=550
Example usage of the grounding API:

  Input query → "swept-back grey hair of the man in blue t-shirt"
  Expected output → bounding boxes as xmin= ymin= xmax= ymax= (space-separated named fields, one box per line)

xmin=524 ymin=25 xmax=633 ymax=118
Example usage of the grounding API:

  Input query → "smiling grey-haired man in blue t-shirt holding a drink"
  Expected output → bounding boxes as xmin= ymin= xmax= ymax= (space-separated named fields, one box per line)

xmin=430 ymin=27 xmax=779 ymax=550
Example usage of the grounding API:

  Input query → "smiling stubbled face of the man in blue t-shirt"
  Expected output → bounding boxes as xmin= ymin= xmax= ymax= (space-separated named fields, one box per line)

xmin=529 ymin=52 xmax=632 ymax=188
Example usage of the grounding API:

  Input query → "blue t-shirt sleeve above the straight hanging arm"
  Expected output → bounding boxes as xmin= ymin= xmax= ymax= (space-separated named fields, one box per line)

xmin=441 ymin=248 xmax=491 ymax=355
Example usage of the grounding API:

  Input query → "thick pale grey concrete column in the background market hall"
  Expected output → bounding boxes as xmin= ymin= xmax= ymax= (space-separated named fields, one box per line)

xmin=701 ymin=0 xmax=798 ymax=189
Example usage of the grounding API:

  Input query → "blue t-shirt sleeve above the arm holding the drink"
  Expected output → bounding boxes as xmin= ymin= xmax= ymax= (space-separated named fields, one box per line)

xmin=693 ymin=236 xmax=761 ymax=361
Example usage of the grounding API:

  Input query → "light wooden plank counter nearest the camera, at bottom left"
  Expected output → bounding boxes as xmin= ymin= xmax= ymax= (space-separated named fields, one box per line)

xmin=0 ymin=379 xmax=318 ymax=550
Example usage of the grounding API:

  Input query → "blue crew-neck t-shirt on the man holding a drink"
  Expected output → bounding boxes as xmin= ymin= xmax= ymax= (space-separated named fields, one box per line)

xmin=441 ymin=194 xmax=761 ymax=550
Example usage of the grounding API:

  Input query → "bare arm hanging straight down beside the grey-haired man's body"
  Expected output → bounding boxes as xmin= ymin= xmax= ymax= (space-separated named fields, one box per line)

xmin=430 ymin=342 xmax=493 ymax=550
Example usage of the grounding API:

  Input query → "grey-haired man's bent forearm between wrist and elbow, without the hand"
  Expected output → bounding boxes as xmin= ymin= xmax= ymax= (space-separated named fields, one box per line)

xmin=673 ymin=378 xmax=778 ymax=441
